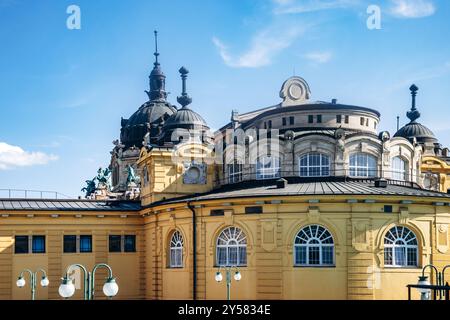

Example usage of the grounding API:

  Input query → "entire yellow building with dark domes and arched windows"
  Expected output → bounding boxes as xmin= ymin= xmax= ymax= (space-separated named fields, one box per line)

xmin=0 ymin=45 xmax=450 ymax=300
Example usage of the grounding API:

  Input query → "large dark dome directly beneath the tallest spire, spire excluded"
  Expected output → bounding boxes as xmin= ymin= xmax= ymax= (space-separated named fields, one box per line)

xmin=120 ymin=101 xmax=177 ymax=148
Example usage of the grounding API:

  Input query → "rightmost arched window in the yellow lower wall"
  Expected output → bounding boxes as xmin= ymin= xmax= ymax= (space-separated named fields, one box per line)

xmin=384 ymin=226 xmax=418 ymax=267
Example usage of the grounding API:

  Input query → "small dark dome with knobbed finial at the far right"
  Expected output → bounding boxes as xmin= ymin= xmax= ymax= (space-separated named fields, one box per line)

xmin=394 ymin=84 xmax=438 ymax=143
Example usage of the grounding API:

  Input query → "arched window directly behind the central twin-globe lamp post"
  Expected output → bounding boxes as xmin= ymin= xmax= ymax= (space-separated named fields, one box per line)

xmin=216 ymin=227 xmax=247 ymax=266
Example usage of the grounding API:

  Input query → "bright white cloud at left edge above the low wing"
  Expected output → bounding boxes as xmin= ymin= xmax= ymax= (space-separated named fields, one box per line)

xmin=0 ymin=142 xmax=58 ymax=170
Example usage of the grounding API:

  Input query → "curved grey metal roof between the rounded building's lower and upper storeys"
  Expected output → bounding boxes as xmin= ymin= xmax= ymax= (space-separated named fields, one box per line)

xmin=148 ymin=178 xmax=450 ymax=207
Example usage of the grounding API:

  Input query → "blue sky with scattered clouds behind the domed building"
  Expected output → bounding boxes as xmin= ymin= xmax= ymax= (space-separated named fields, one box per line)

xmin=0 ymin=0 xmax=450 ymax=196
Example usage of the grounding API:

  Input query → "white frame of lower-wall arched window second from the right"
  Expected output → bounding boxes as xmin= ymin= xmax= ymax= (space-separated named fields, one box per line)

xmin=294 ymin=224 xmax=336 ymax=267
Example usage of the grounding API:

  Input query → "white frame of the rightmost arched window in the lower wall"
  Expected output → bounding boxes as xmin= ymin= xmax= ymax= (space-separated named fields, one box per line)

xmin=384 ymin=226 xmax=419 ymax=268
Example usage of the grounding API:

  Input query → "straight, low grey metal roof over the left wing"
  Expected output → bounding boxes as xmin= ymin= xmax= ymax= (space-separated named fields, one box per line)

xmin=0 ymin=199 xmax=141 ymax=211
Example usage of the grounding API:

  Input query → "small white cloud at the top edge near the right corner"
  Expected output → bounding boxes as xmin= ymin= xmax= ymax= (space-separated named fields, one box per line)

xmin=390 ymin=0 xmax=436 ymax=18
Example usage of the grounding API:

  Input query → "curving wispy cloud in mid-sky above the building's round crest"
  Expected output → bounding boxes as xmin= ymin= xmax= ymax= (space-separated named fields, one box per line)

xmin=212 ymin=26 xmax=303 ymax=68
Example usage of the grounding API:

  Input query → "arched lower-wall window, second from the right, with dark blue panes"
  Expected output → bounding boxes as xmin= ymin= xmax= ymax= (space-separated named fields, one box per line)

xmin=294 ymin=225 xmax=334 ymax=266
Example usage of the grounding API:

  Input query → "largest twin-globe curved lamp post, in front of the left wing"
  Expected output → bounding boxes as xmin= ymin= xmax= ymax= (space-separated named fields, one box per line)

xmin=58 ymin=263 xmax=119 ymax=300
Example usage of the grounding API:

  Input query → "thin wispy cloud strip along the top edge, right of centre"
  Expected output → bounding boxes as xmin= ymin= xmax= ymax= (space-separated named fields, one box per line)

xmin=273 ymin=0 xmax=360 ymax=14
